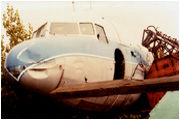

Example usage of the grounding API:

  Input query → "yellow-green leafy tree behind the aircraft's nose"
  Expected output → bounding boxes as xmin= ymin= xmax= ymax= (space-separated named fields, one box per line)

xmin=1 ymin=3 xmax=33 ymax=77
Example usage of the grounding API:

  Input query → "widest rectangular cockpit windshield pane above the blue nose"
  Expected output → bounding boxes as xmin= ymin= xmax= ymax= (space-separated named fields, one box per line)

xmin=50 ymin=23 xmax=79 ymax=35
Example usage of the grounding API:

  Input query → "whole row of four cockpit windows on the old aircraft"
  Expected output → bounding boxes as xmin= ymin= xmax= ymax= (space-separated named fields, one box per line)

xmin=33 ymin=23 xmax=108 ymax=43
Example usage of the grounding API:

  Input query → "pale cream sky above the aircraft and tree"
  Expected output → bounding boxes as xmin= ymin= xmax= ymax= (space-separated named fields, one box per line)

xmin=1 ymin=1 xmax=179 ymax=45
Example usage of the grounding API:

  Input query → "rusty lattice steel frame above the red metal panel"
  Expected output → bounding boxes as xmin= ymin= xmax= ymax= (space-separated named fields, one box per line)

xmin=142 ymin=26 xmax=179 ymax=59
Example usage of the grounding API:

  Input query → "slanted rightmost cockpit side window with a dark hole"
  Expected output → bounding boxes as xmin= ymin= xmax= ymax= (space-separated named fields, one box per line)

xmin=95 ymin=24 xmax=108 ymax=43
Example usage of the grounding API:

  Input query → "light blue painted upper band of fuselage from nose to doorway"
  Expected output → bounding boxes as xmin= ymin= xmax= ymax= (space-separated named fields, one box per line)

xmin=6 ymin=37 xmax=114 ymax=67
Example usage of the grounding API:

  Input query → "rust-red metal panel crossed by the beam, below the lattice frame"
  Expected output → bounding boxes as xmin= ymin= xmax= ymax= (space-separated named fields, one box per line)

xmin=146 ymin=51 xmax=179 ymax=109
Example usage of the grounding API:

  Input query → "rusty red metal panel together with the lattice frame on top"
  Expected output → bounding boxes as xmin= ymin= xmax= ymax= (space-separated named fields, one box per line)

xmin=142 ymin=26 xmax=179 ymax=109
